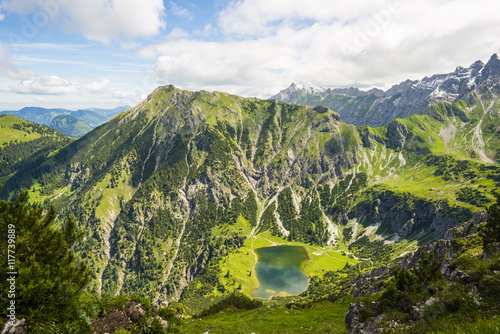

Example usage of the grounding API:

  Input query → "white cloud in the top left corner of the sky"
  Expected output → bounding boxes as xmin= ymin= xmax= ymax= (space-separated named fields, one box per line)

xmin=2 ymin=0 xmax=166 ymax=43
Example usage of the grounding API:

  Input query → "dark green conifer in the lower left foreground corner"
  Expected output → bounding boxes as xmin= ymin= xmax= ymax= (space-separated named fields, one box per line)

xmin=0 ymin=190 xmax=90 ymax=330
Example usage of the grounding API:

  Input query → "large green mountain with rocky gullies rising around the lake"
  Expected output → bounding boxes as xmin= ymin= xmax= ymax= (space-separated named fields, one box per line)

xmin=2 ymin=86 xmax=500 ymax=311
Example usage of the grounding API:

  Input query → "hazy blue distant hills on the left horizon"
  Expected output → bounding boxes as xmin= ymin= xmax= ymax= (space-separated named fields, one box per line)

xmin=0 ymin=106 xmax=130 ymax=138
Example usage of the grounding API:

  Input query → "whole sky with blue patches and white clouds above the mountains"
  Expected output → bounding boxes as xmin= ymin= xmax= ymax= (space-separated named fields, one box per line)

xmin=0 ymin=0 xmax=500 ymax=110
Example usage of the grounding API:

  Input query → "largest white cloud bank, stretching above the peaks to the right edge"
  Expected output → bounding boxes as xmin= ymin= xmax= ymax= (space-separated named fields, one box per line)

xmin=138 ymin=0 xmax=500 ymax=97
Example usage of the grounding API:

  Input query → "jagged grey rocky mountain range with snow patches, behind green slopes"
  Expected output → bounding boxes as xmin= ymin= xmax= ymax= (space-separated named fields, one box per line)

xmin=271 ymin=54 xmax=500 ymax=126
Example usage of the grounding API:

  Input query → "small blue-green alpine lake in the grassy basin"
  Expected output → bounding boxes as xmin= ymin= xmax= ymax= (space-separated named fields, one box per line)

xmin=252 ymin=246 xmax=309 ymax=298
